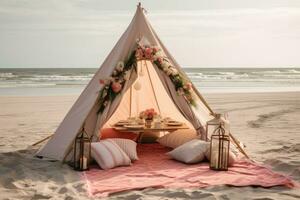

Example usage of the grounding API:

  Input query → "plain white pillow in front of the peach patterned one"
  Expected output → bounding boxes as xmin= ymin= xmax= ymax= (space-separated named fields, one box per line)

xmin=167 ymin=139 xmax=209 ymax=164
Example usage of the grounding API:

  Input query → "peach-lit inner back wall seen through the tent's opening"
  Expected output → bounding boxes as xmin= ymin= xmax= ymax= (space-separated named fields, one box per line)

xmin=103 ymin=60 xmax=193 ymax=129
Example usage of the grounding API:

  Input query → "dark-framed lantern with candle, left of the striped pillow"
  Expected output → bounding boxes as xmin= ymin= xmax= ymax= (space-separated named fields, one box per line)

xmin=73 ymin=128 xmax=91 ymax=171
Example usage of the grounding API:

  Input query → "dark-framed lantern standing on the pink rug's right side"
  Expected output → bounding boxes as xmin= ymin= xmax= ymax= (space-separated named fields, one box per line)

xmin=209 ymin=123 xmax=230 ymax=171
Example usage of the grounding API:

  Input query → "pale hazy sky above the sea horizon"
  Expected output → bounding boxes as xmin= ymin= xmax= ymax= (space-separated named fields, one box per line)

xmin=0 ymin=0 xmax=300 ymax=68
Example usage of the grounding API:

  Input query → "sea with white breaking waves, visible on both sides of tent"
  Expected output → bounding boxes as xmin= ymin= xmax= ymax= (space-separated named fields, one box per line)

xmin=0 ymin=68 xmax=300 ymax=96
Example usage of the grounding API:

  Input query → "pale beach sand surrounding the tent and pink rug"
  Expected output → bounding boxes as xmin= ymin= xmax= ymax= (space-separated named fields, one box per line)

xmin=0 ymin=92 xmax=300 ymax=199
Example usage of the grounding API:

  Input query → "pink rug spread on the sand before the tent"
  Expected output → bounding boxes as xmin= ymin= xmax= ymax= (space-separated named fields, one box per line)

xmin=83 ymin=144 xmax=294 ymax=197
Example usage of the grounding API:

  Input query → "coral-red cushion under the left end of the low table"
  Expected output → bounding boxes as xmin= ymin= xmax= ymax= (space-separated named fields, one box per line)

xmin=100 ymin=128 xmax=138 ymax=141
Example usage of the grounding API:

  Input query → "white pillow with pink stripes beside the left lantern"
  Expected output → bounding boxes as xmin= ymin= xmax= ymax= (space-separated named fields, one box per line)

xmin=91 ymin=140 xmax=131 ymax=169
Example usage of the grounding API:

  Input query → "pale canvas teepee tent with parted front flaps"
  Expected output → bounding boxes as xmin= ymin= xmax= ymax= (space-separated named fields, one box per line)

xmin=37 ymin=4 xmax=241 ymax=161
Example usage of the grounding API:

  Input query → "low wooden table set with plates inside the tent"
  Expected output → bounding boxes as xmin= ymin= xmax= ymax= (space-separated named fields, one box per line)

xmin=112 ymin=123 xmax=189 ymax=143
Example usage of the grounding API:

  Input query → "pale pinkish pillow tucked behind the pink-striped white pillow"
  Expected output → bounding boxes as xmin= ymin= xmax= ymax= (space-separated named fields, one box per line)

xmin=107 ymin=138 xmax=139 ymax=160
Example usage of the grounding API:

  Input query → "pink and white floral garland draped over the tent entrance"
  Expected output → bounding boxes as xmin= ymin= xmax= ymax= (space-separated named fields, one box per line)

xmin=98 ymin=41 xmax=196 ymax=112
